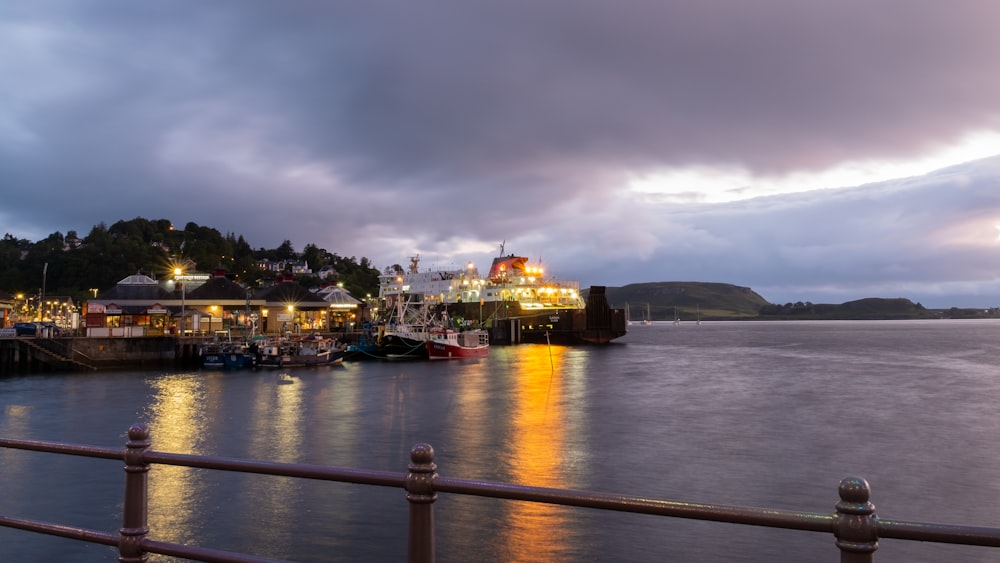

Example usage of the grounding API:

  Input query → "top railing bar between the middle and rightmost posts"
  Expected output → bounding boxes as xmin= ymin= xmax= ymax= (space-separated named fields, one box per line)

xmin=434 ymin=475 xmax=836 ymax=533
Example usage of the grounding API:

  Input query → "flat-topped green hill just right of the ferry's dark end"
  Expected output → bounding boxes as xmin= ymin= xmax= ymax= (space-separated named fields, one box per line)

xmin=606 ymin=282 xmax=769 ymax=321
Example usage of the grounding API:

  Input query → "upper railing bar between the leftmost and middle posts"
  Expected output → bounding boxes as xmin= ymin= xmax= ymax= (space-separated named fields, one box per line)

xmin=143 ymin=451 xmax=406 ymax=488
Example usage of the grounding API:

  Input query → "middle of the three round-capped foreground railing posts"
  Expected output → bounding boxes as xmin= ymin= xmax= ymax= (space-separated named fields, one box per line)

xmin=406 ymin=444 xmax=437 ymax=563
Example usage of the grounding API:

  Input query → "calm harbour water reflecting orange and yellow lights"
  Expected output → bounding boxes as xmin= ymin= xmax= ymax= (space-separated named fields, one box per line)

xmin=0 ymin=321 xmax=1000 ymax=562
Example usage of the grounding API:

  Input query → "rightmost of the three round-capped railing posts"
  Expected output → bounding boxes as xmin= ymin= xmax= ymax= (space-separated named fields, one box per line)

xmin=834 ymin=477 xmax=878 ymax=563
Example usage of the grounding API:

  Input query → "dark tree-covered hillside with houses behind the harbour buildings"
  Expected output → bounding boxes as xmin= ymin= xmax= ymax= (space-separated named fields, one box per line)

xmin=0 ymin=218 xmax=379 ymax=302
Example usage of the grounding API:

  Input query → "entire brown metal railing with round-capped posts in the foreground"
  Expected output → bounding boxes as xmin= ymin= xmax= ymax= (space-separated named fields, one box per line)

xmin=0 ymin=424 xmax=1000 ymax=563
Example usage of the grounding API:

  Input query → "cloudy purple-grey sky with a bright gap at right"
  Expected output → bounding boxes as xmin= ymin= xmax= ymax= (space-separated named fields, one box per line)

xmin=0 ymin=0 xmax=1000 ymax=307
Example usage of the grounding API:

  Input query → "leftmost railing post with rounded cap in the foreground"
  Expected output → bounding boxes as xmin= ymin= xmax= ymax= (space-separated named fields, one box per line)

xmin=118 ymin=424 xmax=150 ymax=563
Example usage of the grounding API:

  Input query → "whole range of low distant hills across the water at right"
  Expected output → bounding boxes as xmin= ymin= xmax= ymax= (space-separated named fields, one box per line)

xmin=605 ymin=282 xmax=984 ymax=321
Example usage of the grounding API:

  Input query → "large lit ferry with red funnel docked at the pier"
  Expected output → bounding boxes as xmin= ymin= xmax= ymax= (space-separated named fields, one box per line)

xmin=379 ymin=245 xmax=626 ymax=344
